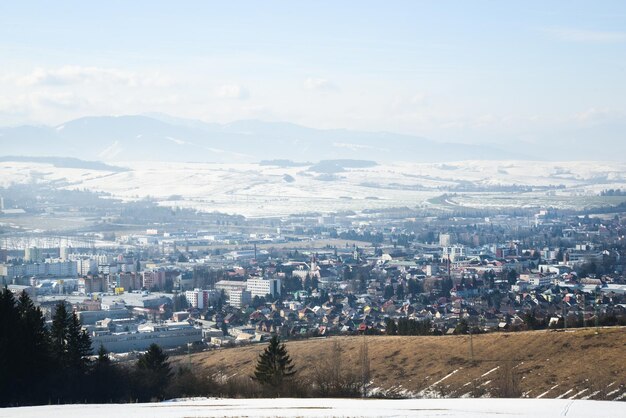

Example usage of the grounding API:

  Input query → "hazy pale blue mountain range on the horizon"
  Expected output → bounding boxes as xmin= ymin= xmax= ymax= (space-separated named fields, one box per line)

xmin=0 ymin=114 xmax=616 ymax=163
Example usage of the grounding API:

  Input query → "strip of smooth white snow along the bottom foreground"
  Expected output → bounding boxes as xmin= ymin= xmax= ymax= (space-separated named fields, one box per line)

xmin=0 ymin=398 xmax=626 ymax=418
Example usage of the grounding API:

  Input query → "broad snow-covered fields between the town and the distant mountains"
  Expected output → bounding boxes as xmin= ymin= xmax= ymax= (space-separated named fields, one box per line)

xmin=0 ymin=161 xmax=626 ymax=216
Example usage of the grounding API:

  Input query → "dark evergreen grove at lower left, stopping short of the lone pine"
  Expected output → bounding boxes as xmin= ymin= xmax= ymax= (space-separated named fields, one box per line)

xmin=0 ymin=288 xmax=205 ymax=407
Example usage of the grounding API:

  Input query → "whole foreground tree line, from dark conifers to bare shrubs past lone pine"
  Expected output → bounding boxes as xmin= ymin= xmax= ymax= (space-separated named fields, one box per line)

xmin=0 ymin=288 xmax=369 ymax=407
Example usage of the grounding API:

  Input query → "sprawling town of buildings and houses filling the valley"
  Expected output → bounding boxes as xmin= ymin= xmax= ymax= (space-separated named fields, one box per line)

xmin=0 ymin=204 xmax=626 ymax=353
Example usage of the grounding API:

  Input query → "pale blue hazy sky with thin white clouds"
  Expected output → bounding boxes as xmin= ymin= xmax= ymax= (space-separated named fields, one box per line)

xmin=0 ymin=0 xmax=626 ymax=145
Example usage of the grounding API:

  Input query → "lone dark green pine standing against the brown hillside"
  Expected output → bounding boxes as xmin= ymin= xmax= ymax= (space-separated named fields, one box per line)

xmin=254 ymin=335 xmax=296 ymax=388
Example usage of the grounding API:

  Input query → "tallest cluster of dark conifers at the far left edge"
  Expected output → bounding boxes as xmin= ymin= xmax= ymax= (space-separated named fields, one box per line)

xmin=0 ymin=288 xmax=91 ymax=405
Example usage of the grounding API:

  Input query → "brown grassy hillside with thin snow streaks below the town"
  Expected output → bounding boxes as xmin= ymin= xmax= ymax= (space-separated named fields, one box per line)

xmin=172 ymin=328 xmax=626 ymax=400
